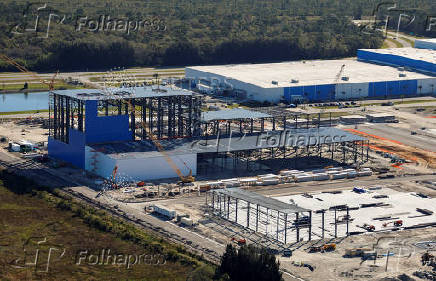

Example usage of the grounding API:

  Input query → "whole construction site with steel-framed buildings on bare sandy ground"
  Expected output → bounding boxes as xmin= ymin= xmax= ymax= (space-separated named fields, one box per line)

xmin=0 ymin=45 xmax=436 ymax=280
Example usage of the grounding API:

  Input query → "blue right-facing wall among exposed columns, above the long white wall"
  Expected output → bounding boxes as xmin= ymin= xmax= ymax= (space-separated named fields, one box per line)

xmin=85 ymin=101 xmax=132 ymax=144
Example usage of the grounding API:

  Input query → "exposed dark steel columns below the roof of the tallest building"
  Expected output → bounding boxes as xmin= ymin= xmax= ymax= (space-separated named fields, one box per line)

xmin=49 ymin=92 xmax=202 ymax=143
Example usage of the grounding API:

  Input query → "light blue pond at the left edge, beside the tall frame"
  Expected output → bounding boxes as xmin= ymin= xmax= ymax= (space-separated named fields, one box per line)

xmin=0 ymin=92 xmax=49 ymax=112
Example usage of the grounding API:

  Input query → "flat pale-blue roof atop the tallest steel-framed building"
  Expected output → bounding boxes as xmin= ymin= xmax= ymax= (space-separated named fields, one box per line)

xmin=49 ymin=87 xmax=192 ymax=100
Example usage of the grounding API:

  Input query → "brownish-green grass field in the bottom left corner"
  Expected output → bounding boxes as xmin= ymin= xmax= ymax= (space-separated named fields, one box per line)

xmin=0 ymin=168 xmax=213 ymax=280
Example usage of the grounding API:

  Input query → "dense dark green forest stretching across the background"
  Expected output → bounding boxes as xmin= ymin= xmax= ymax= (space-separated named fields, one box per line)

xmin=0 ymin=0 xmax=436 ymax=71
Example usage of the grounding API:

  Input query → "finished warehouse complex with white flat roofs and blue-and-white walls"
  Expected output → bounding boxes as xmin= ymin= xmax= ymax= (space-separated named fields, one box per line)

xmin=186 ymin=42 xmax=436 ymax=103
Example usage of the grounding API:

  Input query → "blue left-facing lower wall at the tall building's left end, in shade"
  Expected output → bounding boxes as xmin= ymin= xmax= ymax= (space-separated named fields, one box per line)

xmin=47 ymin=129 xmax=85 ymax=169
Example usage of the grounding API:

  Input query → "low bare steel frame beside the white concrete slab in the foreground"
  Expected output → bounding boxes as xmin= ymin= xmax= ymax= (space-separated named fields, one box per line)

xmin=205 ymin=188 xmax=353 ymax=245
